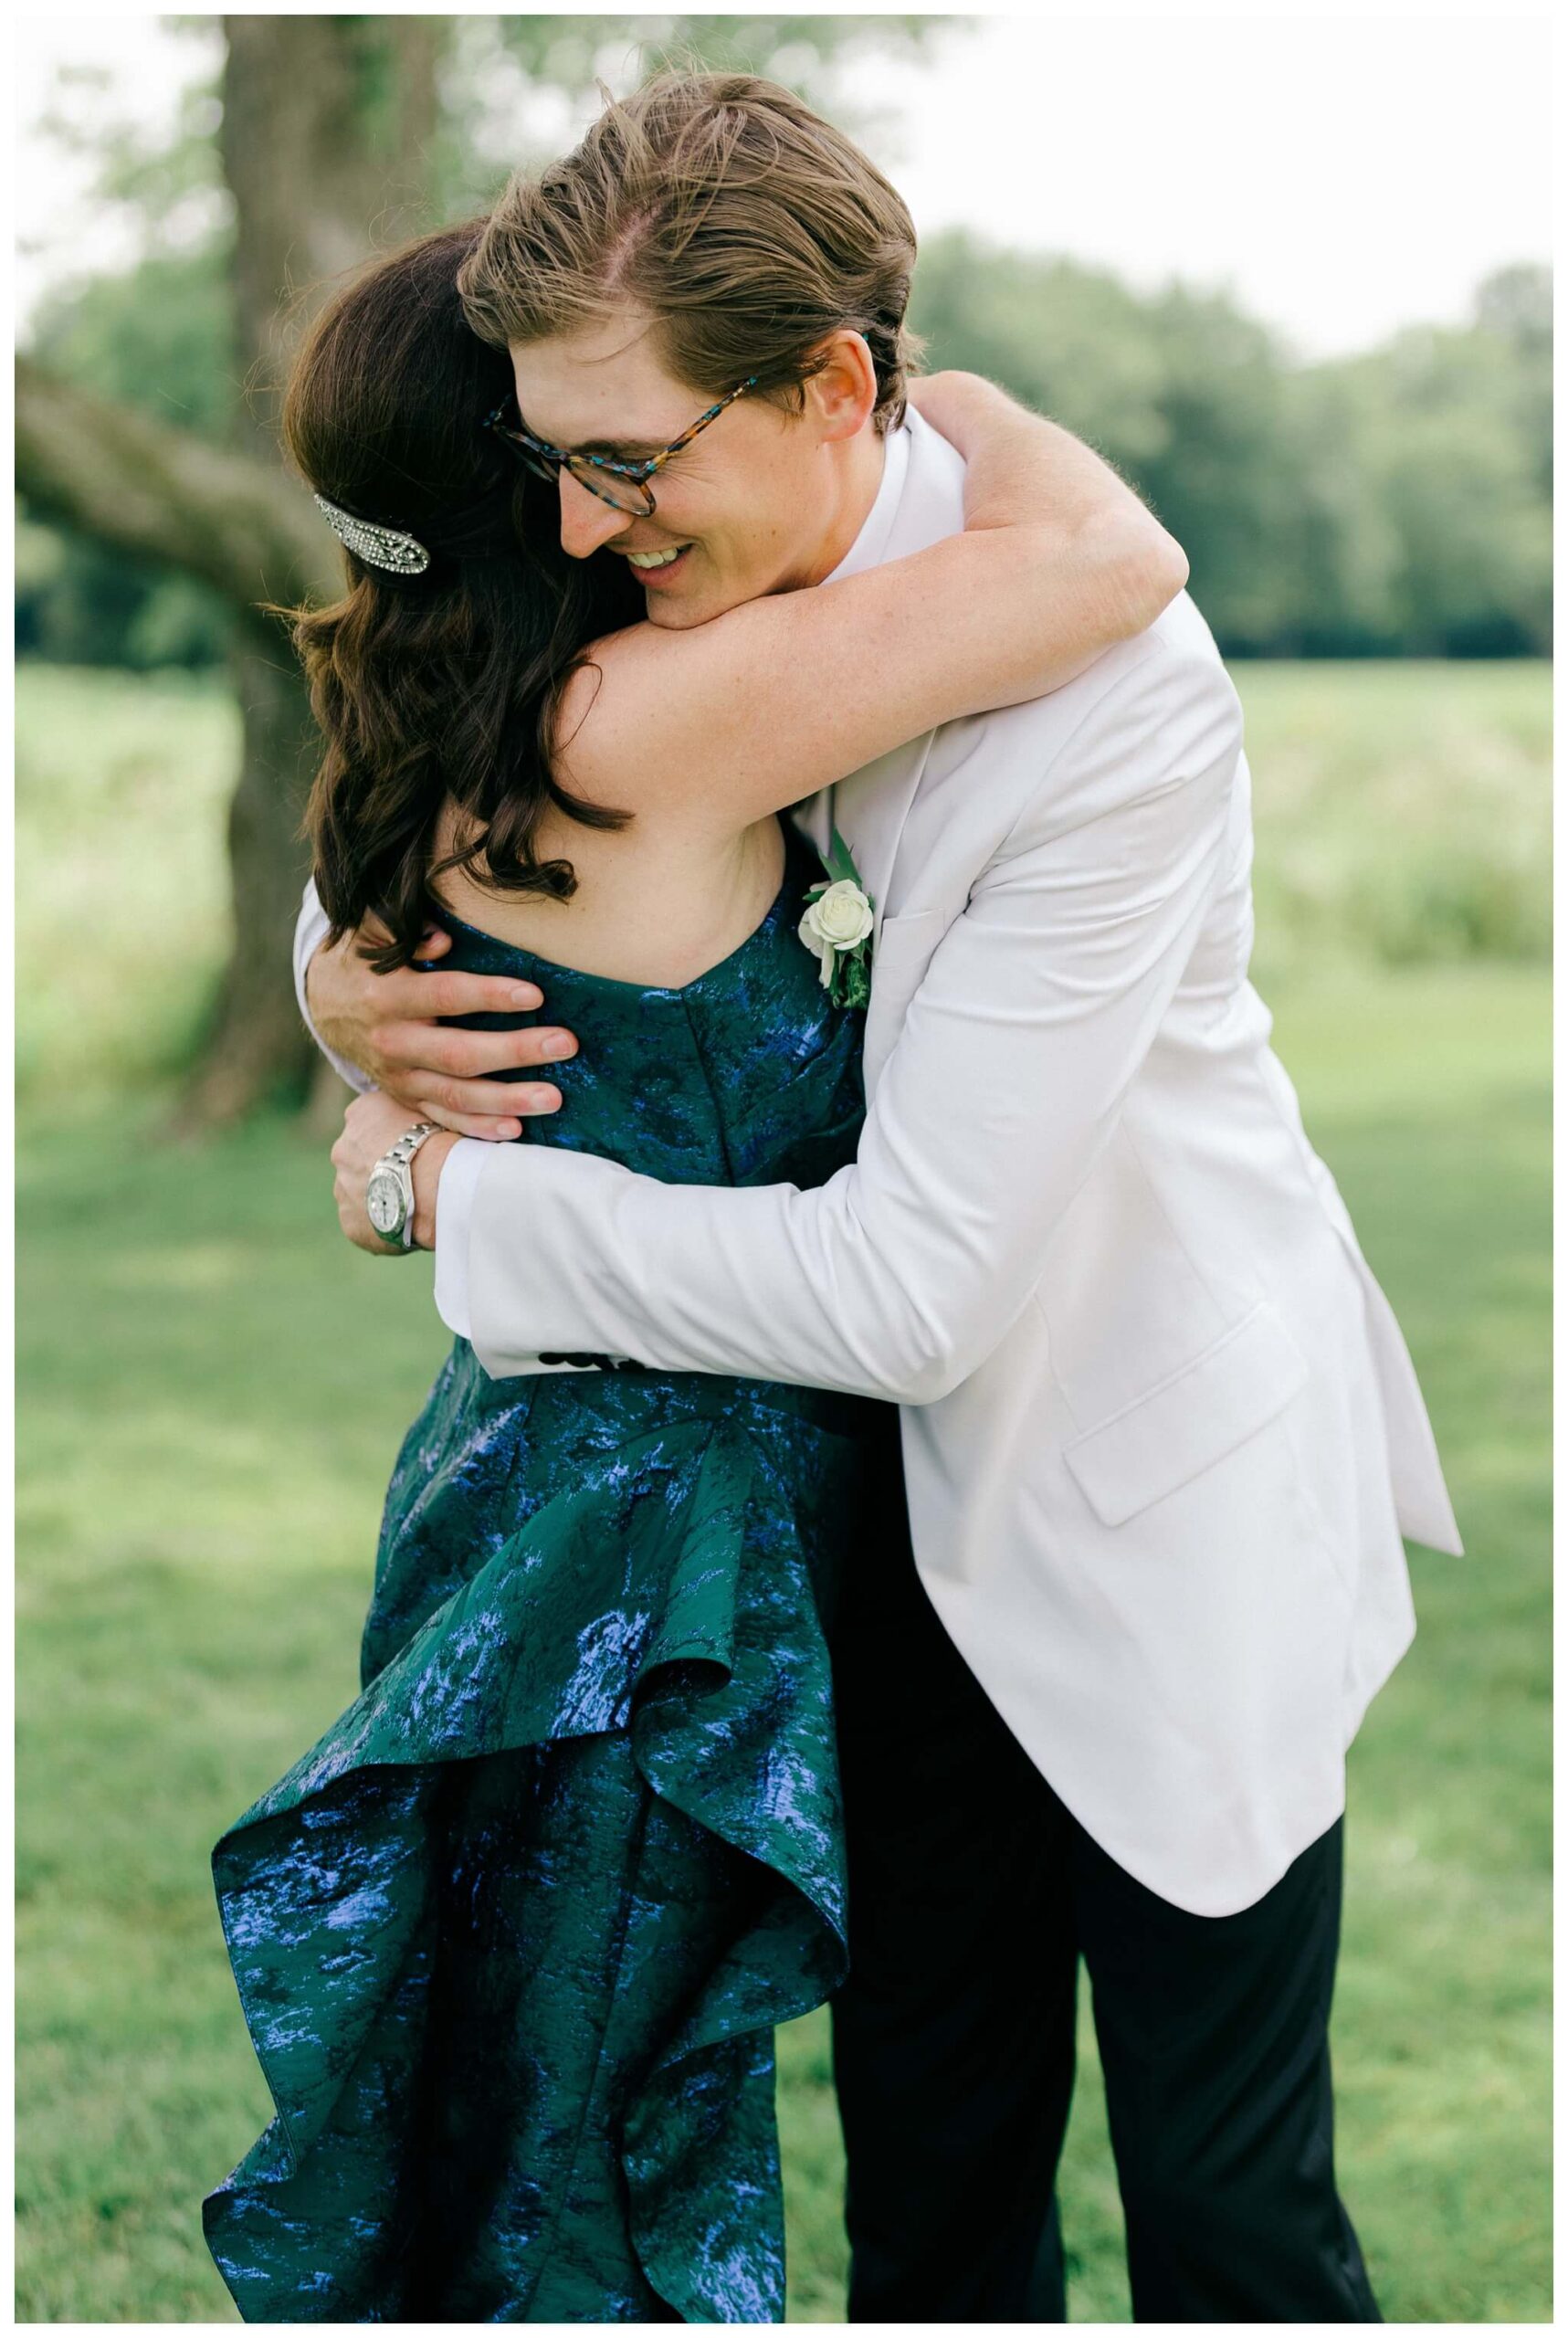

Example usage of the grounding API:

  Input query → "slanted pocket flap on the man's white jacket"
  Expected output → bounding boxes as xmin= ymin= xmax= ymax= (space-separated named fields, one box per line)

xmin=1063 ymin=1300 xmax=1306 ymax=1527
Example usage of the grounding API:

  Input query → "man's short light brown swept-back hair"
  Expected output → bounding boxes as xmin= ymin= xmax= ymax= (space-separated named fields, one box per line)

xmin=458 ymin=72 xmax=919 ymax=430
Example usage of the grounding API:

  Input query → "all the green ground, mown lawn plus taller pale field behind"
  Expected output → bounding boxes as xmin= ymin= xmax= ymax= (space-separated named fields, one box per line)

xmin=16 ymin=667 xmax=1552 ymax=2322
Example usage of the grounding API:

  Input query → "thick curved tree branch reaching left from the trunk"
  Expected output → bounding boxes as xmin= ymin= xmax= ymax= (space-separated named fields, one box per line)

xmin=16 ymin=358 xmax=343 ymax=610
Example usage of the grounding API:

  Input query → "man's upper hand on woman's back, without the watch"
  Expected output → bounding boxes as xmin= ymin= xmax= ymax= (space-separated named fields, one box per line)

xmin=306 ymin=926 xmax=577 ymax=1141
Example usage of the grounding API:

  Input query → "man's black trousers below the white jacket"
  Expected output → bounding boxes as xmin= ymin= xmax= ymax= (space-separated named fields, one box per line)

xmin=832 ymin=1421 xmax=1381 ymax=2322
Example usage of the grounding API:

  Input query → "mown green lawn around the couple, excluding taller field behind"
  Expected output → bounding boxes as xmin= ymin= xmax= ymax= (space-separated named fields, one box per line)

xmin=18 ymin=970 xmax=1550 ymax=2322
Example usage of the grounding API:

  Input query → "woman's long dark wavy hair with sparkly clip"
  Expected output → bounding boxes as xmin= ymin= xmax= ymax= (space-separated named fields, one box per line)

xmin=283 ymin=220 xmax=643 ymax=973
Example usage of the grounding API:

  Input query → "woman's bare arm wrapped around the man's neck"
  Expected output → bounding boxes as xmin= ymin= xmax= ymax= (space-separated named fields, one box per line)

xmin=556 ymin=374 xmax=1187 ymax=830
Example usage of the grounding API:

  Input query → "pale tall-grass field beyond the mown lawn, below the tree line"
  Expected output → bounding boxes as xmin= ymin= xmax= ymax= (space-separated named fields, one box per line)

xmin=16 ymin=659 xmax=1552 ymax=1111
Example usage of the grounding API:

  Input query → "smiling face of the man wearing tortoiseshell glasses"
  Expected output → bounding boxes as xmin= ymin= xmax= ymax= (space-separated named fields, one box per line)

xmin=511 ymin=313 xmax=881 ymax=627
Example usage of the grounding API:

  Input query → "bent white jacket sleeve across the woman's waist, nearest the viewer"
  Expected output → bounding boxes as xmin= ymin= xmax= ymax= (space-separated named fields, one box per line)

xmin=460 ymin=643 xmax=1241 ymax=1406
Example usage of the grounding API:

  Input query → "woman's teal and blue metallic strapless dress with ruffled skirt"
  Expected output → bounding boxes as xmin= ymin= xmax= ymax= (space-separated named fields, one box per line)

xmin=204 ymin=832 xmax=886 ymax=2322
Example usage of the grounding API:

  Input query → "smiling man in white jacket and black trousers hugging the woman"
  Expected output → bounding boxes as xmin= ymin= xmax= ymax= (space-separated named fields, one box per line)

xmin=297 ymin=68 xmax=1460 ymax=2322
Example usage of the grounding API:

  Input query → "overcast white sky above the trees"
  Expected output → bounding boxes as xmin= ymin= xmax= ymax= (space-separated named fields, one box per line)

xmin=16 ymin=7 xmax=1552 ymax=355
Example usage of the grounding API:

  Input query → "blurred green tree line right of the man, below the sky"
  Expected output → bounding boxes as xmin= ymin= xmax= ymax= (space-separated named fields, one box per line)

xmin=914 ymin=231 xmax=1552 ymax=657
